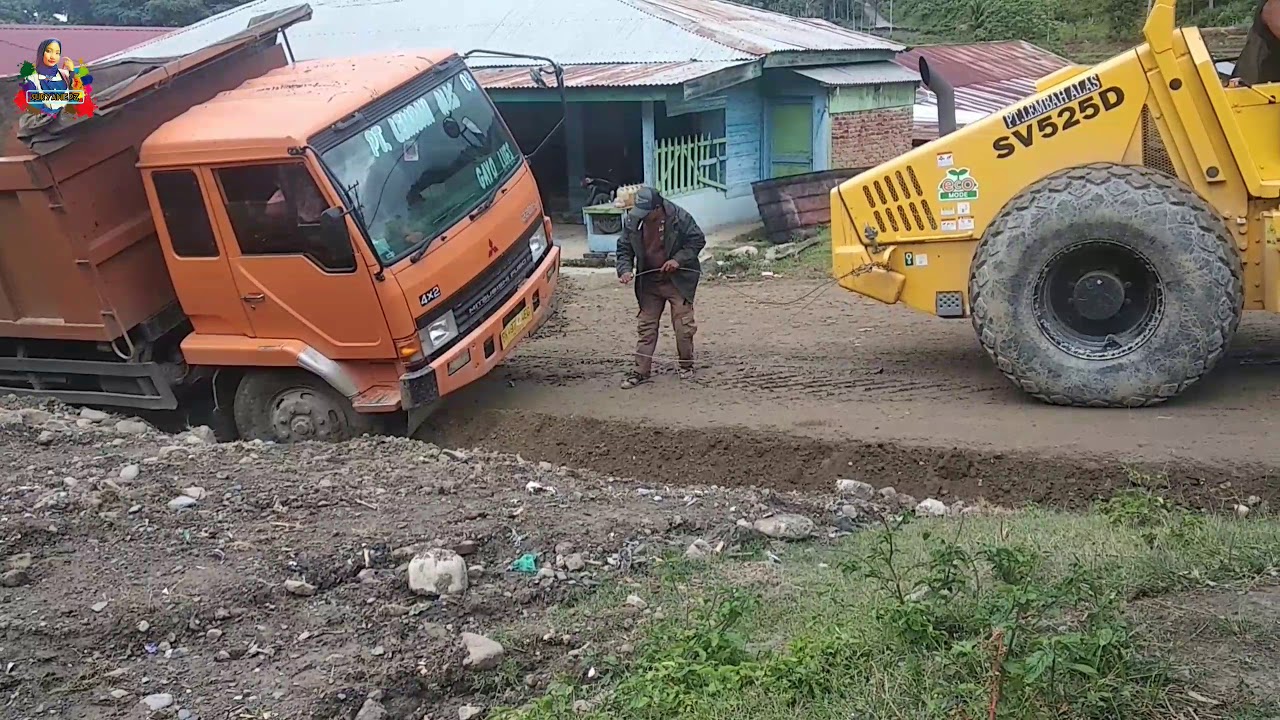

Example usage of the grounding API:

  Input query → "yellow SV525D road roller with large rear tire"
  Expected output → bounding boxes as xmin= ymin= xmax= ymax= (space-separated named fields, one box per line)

xmin=831 ymin=0 xmax=1280 ymax=407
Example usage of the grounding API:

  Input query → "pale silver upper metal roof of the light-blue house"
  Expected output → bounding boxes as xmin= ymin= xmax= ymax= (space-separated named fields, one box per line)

xmin=97 ymin=0 xmax=900 ymax=67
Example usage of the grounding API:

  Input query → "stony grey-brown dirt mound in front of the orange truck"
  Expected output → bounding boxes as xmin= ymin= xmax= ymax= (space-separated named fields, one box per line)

xmin=0 ymin=400 xmax=860 ymax=719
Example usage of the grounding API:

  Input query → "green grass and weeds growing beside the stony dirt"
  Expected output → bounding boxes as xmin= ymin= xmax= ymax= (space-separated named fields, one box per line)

xmin=498 ymin=491 xmax=1280 ymax=720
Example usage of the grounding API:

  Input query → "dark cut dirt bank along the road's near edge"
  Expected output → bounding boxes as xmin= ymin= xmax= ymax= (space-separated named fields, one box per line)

xmin=419 ymin=410 xmax=1280 ymax=510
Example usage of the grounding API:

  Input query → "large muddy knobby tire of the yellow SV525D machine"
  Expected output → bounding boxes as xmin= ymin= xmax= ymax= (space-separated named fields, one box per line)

xmin=969 ymin=164 xmax=1244 ymax=407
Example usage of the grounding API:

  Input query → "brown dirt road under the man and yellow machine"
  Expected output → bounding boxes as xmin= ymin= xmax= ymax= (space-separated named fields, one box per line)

xmin=426 ymin=273 xmax=1280 ymax=505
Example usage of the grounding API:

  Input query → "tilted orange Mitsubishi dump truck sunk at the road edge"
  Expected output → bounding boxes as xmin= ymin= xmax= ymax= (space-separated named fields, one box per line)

xmin=0 ymin=5 xmax=563 ymax=442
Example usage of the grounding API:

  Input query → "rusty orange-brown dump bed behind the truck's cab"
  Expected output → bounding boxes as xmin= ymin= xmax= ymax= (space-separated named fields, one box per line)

xmin=0 ymin=5 xmax=311 ymax=342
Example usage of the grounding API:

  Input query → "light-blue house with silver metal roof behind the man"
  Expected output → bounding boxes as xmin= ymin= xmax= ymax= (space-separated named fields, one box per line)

xmin=99 ymin=0 xmax=919 ymax=228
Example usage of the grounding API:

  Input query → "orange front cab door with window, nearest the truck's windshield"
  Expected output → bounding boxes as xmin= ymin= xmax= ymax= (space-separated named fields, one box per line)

xmin=214 ymin=161 xmax=396 ymax=360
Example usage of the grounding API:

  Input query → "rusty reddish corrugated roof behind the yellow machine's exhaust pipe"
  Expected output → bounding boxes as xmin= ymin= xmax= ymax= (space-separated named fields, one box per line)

xmin=895 ymin=40 xmax=1071 ymax=145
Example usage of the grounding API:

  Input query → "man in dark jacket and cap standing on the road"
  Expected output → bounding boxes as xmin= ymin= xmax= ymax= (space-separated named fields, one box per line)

xmin=617 ymin=187 xmax=707 ymax=389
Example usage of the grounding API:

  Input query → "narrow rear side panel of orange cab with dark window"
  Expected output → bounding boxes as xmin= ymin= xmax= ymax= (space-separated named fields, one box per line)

xmin=147 ymin=169 xmax=253 ymax=336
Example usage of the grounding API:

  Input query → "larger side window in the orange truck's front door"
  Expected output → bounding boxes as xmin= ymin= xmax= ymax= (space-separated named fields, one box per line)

xmin=215 ymin=163 xmax=356 ymax=273
